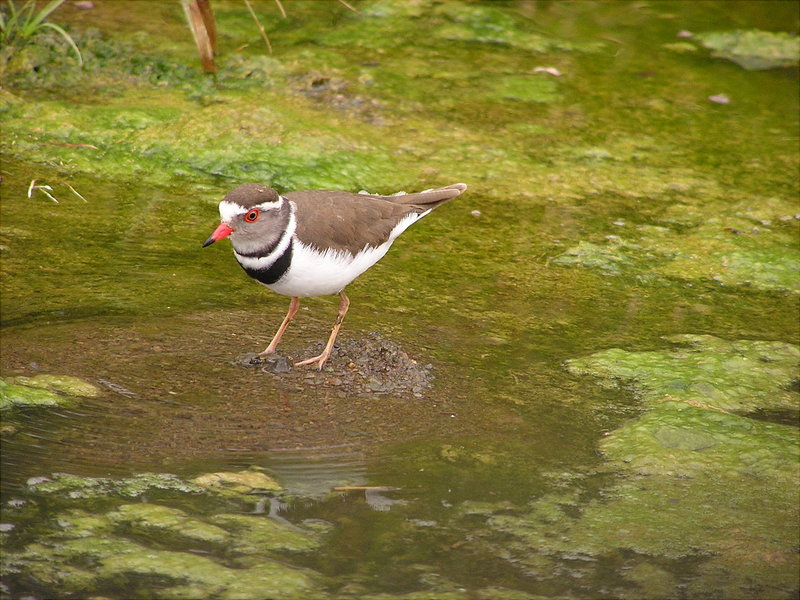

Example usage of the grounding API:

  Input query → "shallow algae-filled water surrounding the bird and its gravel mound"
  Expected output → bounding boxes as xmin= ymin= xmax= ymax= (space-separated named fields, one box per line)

xmin=0 ymin=2 xmax=800 ymax=598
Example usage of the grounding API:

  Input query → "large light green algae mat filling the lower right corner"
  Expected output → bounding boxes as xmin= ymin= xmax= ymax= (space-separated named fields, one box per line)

xmin=459 ymin=335 xmax=800 ymax=598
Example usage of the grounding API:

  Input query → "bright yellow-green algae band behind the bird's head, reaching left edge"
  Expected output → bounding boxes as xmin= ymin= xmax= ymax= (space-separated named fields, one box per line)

xmin=4 ymin=92 xmax=404 ymax=189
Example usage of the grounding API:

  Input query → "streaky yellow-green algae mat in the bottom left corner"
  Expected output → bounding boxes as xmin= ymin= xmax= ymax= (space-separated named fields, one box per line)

xmin=2 ymin=474 xmax=324 ymax=598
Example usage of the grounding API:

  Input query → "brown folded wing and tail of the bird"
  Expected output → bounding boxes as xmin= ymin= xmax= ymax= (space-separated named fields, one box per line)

xmin=285 ymin=184 xmax=466 ymax=254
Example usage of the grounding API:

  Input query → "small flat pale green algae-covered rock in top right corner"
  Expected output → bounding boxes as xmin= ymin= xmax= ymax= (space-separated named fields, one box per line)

xmin=697 ymin=29 xmax=800 ymax=71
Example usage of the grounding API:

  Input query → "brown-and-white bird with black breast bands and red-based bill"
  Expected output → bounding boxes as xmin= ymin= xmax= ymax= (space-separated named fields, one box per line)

xmin=203 ymin=183 xmax=467 ymax=371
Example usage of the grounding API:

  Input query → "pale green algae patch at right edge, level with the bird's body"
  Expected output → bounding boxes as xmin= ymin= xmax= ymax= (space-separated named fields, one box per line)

xmin=550 ymin=197 xmax=800 ymax=292
